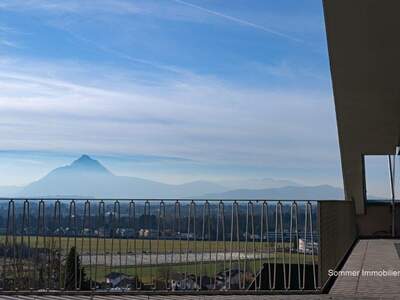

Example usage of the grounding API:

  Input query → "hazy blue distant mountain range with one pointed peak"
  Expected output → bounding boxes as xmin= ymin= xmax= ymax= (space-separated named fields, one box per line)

xmin=0 ymin=155 xmax=344 ymax=200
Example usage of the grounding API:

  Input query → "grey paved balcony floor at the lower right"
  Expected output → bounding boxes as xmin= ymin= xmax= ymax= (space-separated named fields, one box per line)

xmin=330 ymin=239 xmax=400 ymax=298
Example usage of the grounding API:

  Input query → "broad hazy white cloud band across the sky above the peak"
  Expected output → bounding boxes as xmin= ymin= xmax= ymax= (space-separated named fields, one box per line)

xmin=0 ymin=59 xmax=338 ymax=171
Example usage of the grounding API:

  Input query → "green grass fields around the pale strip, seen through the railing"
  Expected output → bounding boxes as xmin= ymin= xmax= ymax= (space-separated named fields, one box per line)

xmin=0 ymin=236 xmax=317 ymax=284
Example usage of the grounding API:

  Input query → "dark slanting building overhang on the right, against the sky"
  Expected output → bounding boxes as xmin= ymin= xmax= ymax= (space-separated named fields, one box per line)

xmin=324 ymin=0 xmax=400 ymax=213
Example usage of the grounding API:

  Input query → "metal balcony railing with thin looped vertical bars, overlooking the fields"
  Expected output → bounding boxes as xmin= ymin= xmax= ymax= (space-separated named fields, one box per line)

xmin=0 ymin=199 xmax=320 ymax=293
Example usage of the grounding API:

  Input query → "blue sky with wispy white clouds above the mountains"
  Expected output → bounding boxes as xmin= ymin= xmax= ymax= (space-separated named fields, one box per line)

xmin=0 ymin=0 xmax=350 ymax=190
